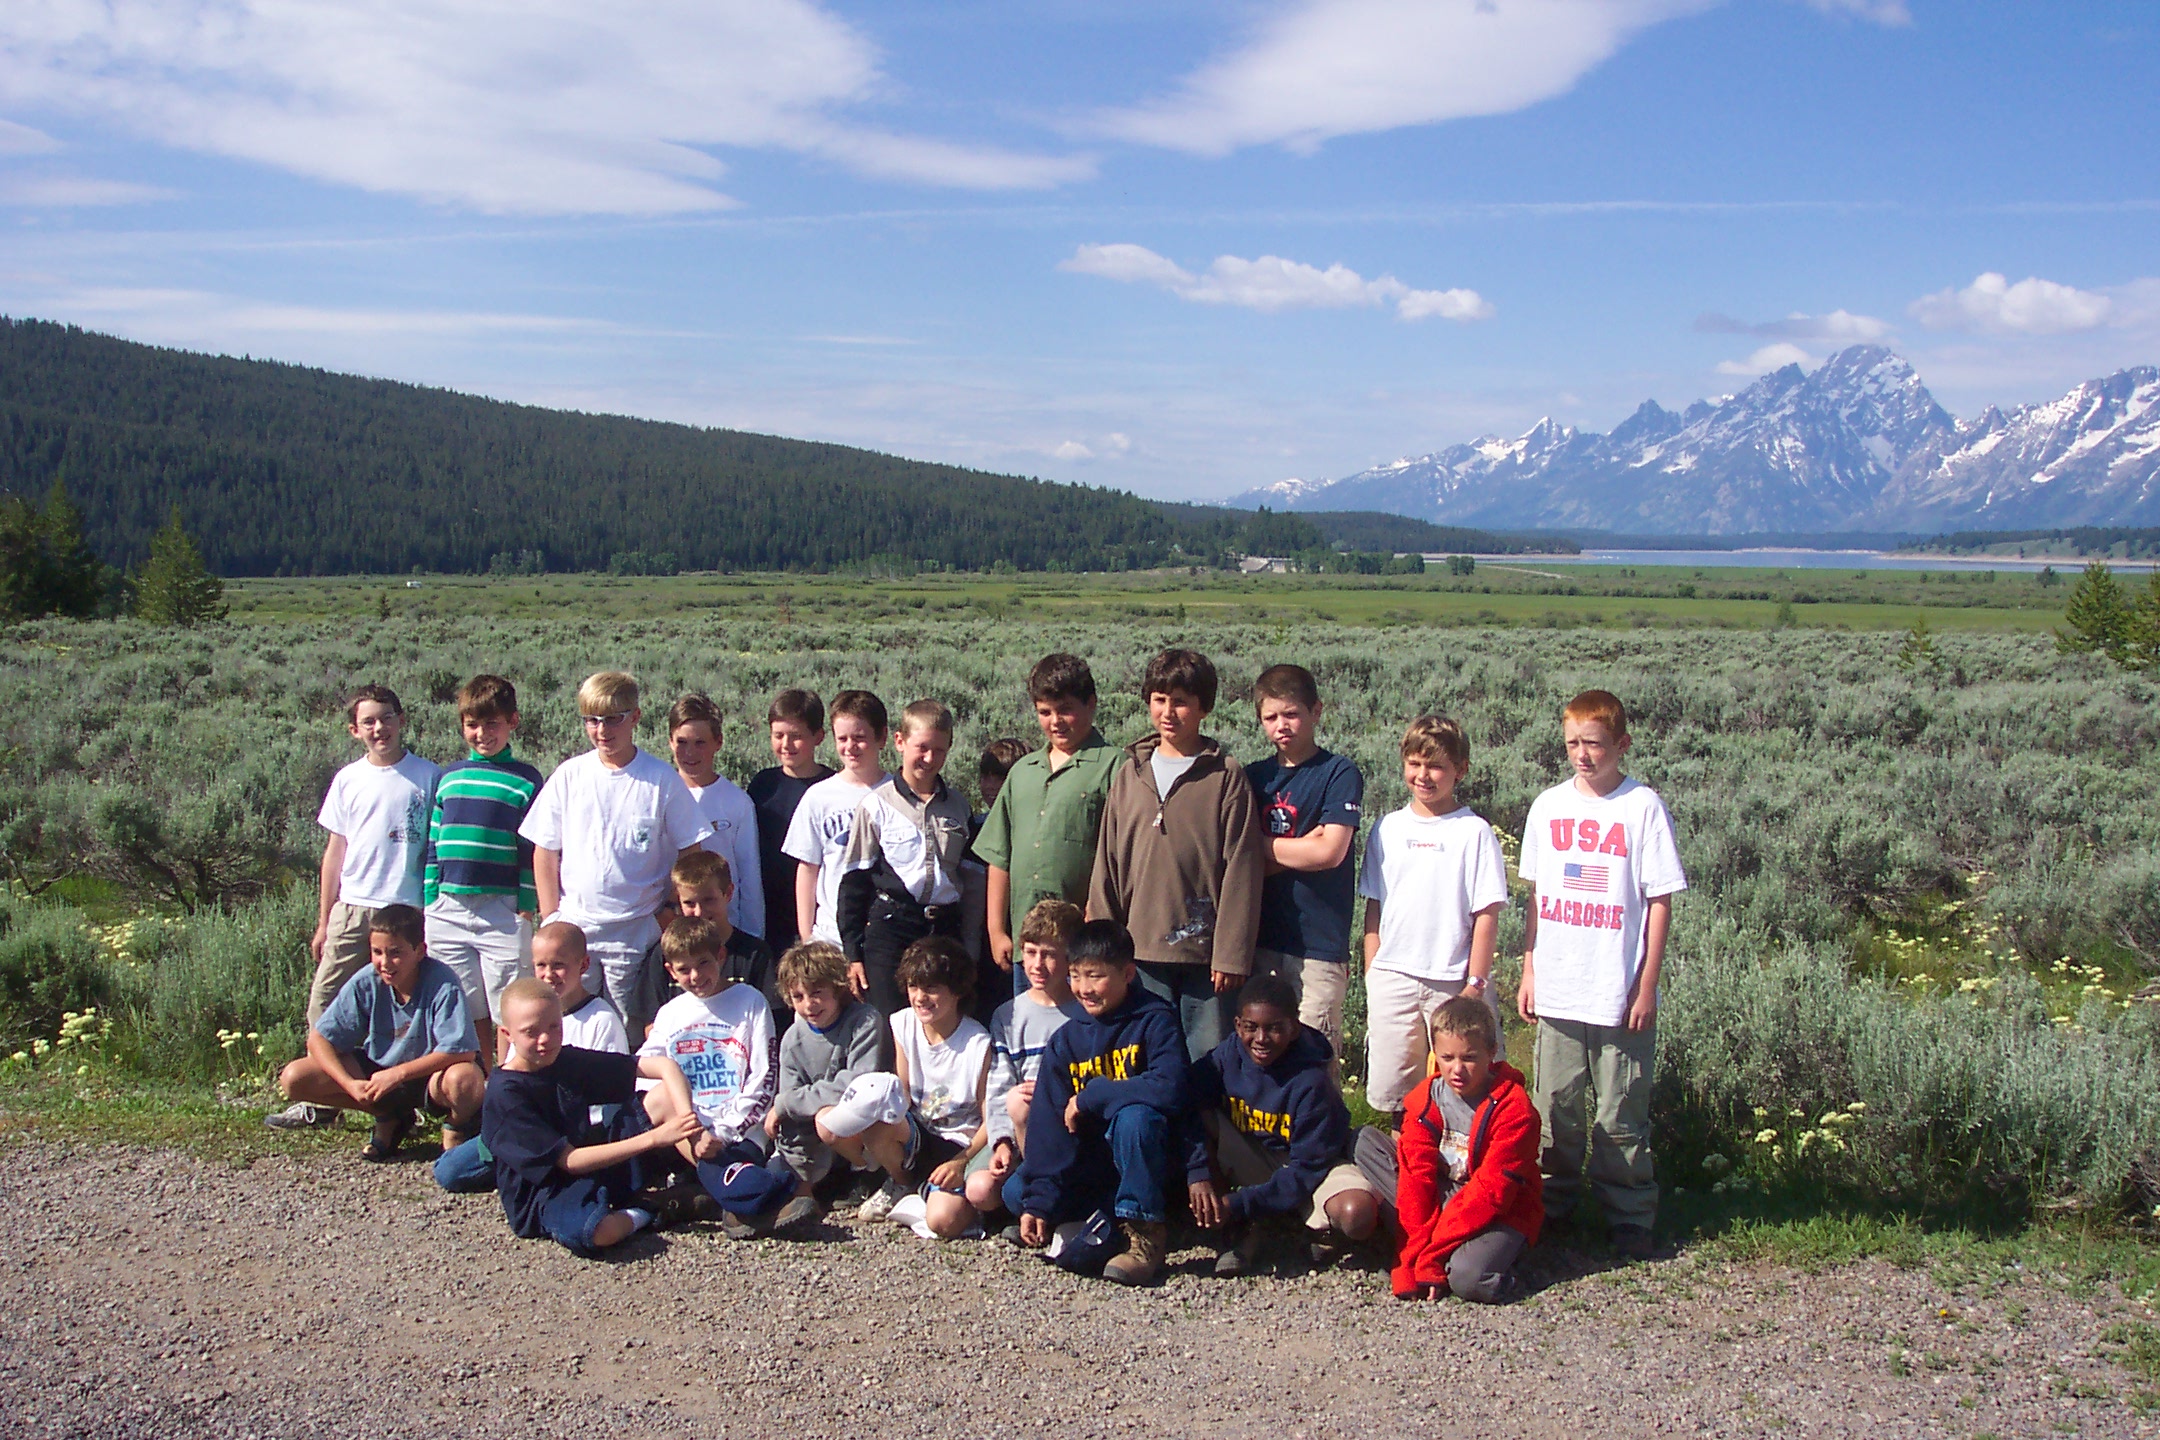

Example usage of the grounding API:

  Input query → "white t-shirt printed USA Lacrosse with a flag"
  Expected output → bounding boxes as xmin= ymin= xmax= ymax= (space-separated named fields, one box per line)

xmin=1521 ymin=779 xmax=1687 ymax=1025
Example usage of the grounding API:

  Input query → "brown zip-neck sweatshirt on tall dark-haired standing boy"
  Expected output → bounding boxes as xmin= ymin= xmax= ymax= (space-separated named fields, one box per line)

xmin=1086 ymin=734 xmax=1266 ymax=976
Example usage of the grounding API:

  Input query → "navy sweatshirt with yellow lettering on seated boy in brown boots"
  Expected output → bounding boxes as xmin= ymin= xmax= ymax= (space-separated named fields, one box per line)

xmin=1020 ymin=980 xmax=1188 ymax=1215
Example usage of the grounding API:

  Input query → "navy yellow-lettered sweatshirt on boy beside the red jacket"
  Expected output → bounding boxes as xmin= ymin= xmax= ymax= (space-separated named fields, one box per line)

xmin=1192 ymin=1025 xmax=1350 ymax=1220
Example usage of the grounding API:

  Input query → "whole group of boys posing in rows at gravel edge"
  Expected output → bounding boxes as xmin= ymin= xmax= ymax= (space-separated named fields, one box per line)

xmin=270 ymin=650 xmax=1687 ymax=1302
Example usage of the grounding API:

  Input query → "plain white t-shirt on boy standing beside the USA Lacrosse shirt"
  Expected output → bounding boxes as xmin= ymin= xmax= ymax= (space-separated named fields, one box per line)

xmin=1356 ymin=805 xmax=1508 ymax=980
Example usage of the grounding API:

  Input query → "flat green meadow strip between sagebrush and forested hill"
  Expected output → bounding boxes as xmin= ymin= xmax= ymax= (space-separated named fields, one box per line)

xmin=229 ymin=557 xmax=2067 ymax=633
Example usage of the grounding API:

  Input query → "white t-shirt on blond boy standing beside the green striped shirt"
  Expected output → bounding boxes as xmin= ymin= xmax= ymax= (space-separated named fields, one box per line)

xmin=518 ymin=749 xmax=706 ymax=930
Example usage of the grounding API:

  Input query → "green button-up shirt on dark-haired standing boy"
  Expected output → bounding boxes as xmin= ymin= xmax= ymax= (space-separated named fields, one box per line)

xmin=974 ymin=730 xmax=1125 ymax=939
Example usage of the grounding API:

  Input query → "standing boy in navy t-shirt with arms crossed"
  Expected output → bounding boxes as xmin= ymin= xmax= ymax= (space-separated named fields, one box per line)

xmin=1244 ymin=665 xmax=1365 ymax=1075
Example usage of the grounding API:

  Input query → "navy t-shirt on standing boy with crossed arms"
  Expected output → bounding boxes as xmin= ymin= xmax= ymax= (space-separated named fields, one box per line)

xmin=1244 ymin=749 xmax=1365 ymax=961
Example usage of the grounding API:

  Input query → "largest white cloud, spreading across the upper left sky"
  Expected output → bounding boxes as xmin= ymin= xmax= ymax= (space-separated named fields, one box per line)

xmin=0 ymin=0 xmax=1091 ymax=214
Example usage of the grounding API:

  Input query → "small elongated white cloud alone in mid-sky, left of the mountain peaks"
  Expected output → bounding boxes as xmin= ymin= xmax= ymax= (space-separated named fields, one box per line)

xmin=1058 ymin=244 xmax=1495 ymax=322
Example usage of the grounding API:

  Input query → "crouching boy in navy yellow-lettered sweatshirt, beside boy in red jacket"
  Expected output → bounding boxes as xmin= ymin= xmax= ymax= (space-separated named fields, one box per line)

xmin=1186 ymin=976 xmax=1380 ymax=1276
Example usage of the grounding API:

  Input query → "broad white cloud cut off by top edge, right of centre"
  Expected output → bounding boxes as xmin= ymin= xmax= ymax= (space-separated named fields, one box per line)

xmin=1097 ymin=0 xmax=1715 ymax=155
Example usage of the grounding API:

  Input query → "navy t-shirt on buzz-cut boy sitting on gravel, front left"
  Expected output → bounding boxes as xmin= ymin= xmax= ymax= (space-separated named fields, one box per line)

xmin=480 ymin=1045 xmax=637 ymax=1239
